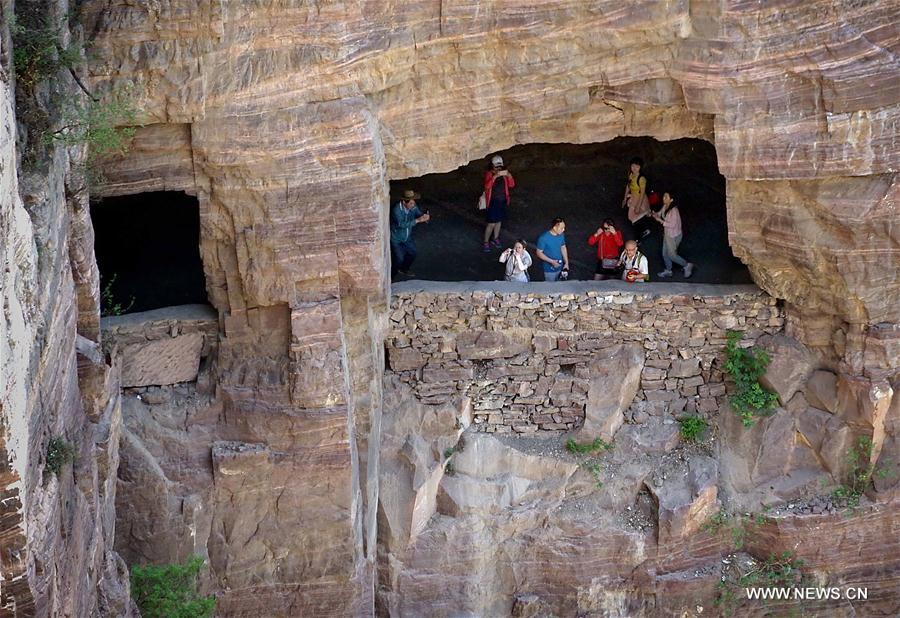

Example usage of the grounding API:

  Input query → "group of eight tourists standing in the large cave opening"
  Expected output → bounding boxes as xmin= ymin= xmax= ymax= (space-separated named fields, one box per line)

xmin=390 ymin=155 xmax=694 ymax=282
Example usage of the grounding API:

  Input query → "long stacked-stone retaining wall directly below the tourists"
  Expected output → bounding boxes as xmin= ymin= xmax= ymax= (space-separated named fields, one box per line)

xmin=385 ymin=281 xmax=784 ymax=433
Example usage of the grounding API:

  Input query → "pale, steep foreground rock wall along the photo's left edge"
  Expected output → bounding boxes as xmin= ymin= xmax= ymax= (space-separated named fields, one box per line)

xmin=0 ymin=1 xmax=131 ymax=616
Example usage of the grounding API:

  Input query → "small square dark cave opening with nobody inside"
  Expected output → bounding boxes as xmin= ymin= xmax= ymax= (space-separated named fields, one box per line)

xmin=91 ymin=191 xmax=208 ymax=315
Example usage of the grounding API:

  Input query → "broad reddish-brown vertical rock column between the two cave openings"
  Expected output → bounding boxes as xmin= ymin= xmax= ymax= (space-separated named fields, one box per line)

xmin=192 ymin=99 xmax=387 ymax=615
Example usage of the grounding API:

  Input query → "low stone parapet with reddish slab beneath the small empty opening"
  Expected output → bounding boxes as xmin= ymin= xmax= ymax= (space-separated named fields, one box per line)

xmin=101 ymin=305 xmax=219 ymax=388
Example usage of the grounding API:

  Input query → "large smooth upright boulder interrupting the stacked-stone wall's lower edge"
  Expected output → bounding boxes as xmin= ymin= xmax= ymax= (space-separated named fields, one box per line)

xmin=574 ymin=344 xmax=644 ymax=442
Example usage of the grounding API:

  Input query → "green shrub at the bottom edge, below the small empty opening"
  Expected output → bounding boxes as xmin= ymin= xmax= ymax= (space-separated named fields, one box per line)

xmin=131 ymin=556 xmax=216 ymax=618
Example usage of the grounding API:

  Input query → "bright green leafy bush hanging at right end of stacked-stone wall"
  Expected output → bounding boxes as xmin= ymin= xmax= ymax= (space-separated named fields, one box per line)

xmin=725 ymin=330 xmax=778 ymax=427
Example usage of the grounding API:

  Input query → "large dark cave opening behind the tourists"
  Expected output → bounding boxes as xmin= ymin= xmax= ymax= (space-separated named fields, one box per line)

xmin=390 ymin=137 xmax=752 ymax=284
